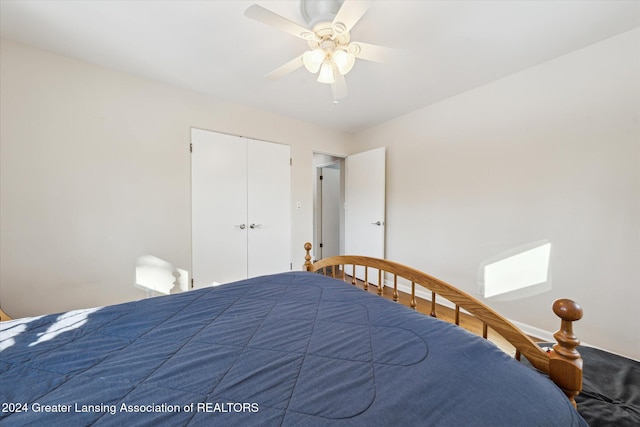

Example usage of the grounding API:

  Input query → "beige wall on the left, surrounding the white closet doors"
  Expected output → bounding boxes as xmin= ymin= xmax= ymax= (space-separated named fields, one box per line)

xmin=0 ymin=41 xmax=351 ymax=317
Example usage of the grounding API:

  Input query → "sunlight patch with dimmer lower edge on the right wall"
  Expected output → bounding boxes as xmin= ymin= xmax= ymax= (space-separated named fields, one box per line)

xmin=478 ymin=241 xmax=551 ymax=300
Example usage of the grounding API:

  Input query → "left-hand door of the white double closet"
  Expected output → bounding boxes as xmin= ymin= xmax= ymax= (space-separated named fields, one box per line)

xmin=191 ymin=129 xmax=249 ymax=288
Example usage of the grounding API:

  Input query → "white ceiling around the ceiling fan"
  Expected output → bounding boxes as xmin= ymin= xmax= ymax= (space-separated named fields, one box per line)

xmin=0 ymin=0 xmax=640 ymax=132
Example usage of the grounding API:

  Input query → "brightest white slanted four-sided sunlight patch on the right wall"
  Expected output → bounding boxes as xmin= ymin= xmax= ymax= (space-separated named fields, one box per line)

xmin=481 ymin=243 xmax=551 ymax=298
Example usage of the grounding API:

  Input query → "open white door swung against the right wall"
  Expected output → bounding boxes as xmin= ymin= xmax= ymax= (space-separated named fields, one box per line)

xmin=345 ymin=147 xmax=386 ymax=283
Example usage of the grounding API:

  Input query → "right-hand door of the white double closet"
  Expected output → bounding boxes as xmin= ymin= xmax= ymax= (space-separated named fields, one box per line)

xmin=247 ymin=140 xmax=291 ymax=277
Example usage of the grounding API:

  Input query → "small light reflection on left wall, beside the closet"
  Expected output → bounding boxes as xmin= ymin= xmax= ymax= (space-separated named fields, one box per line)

xmin=135 ymin=255 xmax=189 ymax=297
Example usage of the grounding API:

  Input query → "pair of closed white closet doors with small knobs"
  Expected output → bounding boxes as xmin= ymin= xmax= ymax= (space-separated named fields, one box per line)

xmin=191 ymin=129 xmax=291 ymax=288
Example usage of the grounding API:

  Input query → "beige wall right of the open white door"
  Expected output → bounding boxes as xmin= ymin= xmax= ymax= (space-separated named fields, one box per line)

xmin=352 ymin=30 xmax=640 ymax=359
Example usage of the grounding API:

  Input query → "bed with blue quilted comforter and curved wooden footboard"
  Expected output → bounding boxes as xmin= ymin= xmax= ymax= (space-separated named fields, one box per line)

xmin=0 ymin=244 xmax=586 ymax=426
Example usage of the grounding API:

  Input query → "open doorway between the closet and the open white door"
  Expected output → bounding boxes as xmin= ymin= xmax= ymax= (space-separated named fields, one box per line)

xmin=312 ymin=153 xmax=345 ymax=260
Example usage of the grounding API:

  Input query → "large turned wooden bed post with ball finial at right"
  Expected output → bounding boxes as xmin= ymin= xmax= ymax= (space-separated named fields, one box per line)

xmin=549 ymin=299 xmax=582 ymax=406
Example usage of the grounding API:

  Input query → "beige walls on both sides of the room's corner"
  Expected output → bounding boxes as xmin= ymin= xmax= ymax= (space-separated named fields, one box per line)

xmin=0 ymin=27 xmax=640 ymax=358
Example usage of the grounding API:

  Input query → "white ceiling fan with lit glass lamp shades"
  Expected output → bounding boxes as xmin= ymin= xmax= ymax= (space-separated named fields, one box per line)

xmin=244 ymin=0 xmax=391 ymax=103
